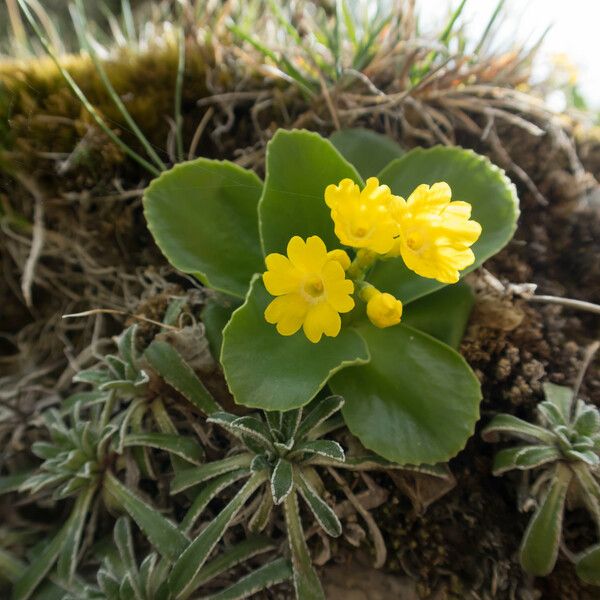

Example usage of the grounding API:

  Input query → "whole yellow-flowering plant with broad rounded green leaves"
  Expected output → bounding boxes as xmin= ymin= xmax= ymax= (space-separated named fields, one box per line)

xmin=144 ymin=130 xmax=518 ymax=464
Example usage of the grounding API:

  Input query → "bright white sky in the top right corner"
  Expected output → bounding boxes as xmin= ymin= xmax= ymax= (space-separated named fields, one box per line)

xmin=417 ymin=0 xmax=600 ymax=109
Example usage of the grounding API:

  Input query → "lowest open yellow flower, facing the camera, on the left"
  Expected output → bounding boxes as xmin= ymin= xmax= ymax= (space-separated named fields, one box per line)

xmin=263 ymin=235 xmax=354 ymax=343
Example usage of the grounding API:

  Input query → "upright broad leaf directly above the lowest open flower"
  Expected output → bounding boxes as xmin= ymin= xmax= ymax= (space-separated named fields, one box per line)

xmin=258 ymin=129 xmax=362 ymax=255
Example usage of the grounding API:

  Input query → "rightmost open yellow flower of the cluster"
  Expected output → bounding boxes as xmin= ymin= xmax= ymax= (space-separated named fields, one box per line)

xmin=389 ymin=182 xmax=481 ymax=283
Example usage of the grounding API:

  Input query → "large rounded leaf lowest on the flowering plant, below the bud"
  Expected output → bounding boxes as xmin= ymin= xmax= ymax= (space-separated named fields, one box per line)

xmin=329 ymin=323 xmax=481 ymax=465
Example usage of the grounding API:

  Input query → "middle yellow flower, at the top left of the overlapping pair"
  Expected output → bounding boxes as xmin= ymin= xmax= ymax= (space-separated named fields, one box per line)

xmin=325 ymin=177 xmax=398 ymax=254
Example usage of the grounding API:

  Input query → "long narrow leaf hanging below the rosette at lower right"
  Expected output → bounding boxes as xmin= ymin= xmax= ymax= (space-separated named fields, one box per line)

xmin=520 ymin=464 xmax=572 ymax=577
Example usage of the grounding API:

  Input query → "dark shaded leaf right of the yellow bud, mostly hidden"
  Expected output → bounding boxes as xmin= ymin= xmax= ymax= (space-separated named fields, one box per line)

xmin=402 ymin=281 xmax=475 ymax=350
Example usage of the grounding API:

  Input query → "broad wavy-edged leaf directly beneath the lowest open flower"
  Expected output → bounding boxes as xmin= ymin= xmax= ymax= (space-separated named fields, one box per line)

xmin=221 ymin=277 xmax=369 ymax=410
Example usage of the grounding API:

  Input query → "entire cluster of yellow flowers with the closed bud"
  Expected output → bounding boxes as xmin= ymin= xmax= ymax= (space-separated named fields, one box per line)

xmin=263 ymin=177 xmax=481 ymax=343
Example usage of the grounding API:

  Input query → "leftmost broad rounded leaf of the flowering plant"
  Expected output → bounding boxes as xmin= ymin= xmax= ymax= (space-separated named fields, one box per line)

xmin=144 ymin=158 xmax=263 ymax=298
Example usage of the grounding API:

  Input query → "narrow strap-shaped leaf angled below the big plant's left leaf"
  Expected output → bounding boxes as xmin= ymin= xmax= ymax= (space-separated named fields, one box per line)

xmin=144 ymin=340 xmax=223 ymax=415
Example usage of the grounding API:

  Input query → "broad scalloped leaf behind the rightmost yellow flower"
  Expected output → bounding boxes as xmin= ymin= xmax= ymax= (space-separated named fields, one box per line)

xmin=368 ymin=146 xmax=519 ymax=304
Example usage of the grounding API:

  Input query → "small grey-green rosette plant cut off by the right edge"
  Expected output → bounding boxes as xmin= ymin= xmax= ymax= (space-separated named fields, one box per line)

xmin=482 ymin=383 xmax=600 ymax=585
